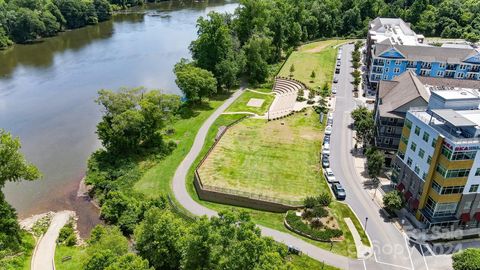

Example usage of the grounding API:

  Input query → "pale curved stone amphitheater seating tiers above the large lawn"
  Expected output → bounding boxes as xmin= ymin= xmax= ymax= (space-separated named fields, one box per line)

xmin=268 ymin=77 xmax=305 ymax=119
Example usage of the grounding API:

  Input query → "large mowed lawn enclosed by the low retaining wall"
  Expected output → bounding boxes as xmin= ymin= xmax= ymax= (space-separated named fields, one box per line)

xmin=199 ymin=109 xmax=328 ymax=203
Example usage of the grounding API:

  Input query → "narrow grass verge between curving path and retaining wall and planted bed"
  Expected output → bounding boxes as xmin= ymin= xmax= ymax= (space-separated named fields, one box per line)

xmin=186 ymin=110 xmax=368 ymax=260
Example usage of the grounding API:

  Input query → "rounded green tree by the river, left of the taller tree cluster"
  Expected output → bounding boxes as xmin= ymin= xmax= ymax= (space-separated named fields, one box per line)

xmin=174 ymin=59 xmax=217 ymax=103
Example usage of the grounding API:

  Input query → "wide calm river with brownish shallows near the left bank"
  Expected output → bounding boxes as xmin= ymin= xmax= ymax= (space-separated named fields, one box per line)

xmin=0 ymin=0 xmax=238 ymax=234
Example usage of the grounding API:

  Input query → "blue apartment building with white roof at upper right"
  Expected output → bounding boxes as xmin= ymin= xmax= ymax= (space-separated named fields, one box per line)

xmin=366 ymin=18 xmax=480 ymax=89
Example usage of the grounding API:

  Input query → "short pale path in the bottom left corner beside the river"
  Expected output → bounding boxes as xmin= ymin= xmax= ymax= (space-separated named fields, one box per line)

xmin=31 ymin=211 xmax=74 ymax=270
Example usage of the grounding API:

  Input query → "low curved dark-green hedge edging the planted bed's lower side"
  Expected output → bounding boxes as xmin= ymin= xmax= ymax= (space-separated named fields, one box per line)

xmin=285 ymin=211 xmax=343 ymax=241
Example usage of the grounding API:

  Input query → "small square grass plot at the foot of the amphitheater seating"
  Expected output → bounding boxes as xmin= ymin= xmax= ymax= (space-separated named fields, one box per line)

xmin=226 ymin=89 xmax=275 ymax=115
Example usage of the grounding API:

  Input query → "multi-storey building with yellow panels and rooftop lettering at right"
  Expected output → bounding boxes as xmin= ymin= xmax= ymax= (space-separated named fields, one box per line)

xmin=392 ymin=85 xmax=480 ymax=229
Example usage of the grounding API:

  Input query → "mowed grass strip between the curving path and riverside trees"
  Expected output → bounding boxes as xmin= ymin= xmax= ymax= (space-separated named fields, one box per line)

xmin=134 ymin=96 xmax=231 ymax=198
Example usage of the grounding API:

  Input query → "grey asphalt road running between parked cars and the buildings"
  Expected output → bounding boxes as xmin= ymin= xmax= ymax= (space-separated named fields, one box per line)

xmin=330 ymin=44 xmax=451 ymax=269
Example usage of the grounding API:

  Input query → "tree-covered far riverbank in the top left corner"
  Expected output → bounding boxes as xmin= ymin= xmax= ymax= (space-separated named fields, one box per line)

xmin=0 ymin=0 xmax=171 ymax=49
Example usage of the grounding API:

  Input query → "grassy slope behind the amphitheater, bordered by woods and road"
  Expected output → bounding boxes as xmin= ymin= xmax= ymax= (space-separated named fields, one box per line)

xmin=278 ymin=40 xmax=349 ymax=89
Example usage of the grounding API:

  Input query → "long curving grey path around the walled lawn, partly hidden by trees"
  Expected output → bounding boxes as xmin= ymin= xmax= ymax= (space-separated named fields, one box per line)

xmin=172 ymin=87 xmax=364 ymax=269
